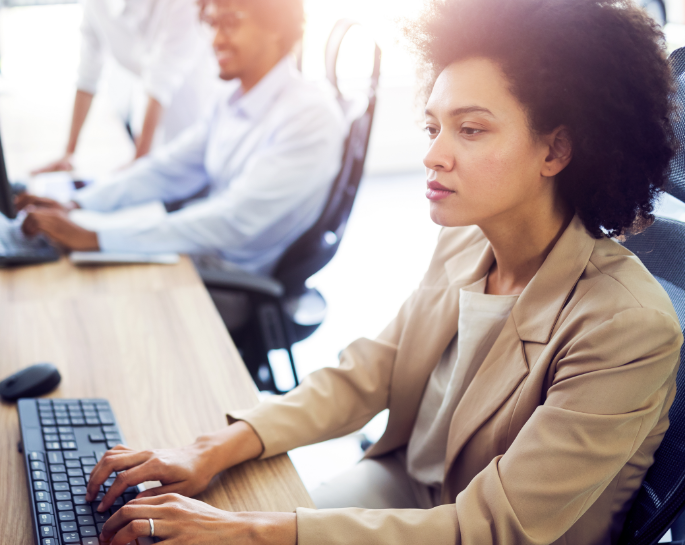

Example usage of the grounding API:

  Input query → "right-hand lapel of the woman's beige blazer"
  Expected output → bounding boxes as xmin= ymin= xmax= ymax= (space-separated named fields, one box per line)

xmin=445 ymin=216 xmax=595 ymax=488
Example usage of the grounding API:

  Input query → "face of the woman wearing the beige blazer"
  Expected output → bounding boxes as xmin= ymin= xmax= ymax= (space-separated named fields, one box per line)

xmin=423 ymin=58 xmax=556 ymax=227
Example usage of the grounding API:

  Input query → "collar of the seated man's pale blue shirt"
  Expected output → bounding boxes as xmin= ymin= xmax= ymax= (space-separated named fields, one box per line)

xmin=229 ymin=55 xmax=297 ymax=120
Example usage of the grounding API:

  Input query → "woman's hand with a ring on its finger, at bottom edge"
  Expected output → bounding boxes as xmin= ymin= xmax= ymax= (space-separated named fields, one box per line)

xmin=100 ymin=494 xmax=297 ymax=545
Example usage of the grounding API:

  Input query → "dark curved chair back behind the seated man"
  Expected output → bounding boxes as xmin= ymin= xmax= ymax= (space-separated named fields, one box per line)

xmin=273 ymin=19 xmax=381 ymax=295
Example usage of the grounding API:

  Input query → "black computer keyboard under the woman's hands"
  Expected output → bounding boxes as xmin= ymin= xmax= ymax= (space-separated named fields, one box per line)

xmin=18 ymin=399 xmax=152 ymax=545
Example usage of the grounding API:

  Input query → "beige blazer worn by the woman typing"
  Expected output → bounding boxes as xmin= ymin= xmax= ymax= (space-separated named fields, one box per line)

xmin=231 ymin=217 xmax=683 ymax=545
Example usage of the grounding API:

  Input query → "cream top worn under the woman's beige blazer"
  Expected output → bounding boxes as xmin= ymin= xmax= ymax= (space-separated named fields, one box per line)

xmin=407 ymin=276 xmax=518 ymax=487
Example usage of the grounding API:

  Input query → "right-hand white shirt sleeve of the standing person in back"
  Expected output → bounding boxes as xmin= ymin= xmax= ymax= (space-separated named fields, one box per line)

xmin=141 ymin=0 xmax=203 ymax=107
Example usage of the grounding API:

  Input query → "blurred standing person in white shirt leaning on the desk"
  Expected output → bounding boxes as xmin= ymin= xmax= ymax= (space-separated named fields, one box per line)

xmin=33 ymin=0 xmax=217 ymax=174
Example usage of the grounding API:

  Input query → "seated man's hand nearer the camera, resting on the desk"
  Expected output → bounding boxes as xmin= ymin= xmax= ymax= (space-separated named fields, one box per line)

xmin=21 ymin=206 xmax=100 ymax=251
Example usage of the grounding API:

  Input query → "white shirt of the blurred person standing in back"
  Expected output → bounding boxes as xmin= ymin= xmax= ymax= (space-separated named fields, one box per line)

xmin=77 ymin=0 xmax=216 ymax=108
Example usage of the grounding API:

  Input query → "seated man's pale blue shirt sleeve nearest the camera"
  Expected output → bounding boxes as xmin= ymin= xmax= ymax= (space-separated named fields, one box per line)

xmin=98 ymin=101 xmax=345 ymax=264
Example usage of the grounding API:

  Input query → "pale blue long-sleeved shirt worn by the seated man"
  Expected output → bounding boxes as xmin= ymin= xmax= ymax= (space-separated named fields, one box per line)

xmin=75 ymin=56 xmax=347 ymax=274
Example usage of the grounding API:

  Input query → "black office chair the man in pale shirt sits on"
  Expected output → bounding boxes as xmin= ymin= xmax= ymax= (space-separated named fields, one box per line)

xmin=196 ymin=19 xmax=381 ymax=393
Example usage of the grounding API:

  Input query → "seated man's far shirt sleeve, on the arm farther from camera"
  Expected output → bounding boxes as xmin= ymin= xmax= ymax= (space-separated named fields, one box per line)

xmin=74 ymin=119 xmax=210 ymax=212
